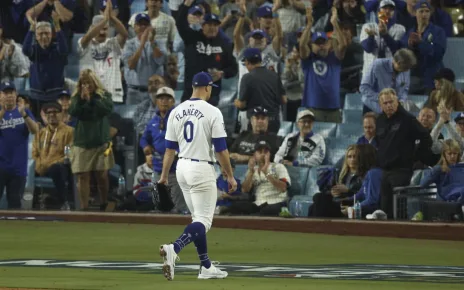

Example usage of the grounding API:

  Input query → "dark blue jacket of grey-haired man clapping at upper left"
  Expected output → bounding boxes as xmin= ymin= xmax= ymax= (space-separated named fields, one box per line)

xmin=23 ymin=31 xmax=68 ymax=101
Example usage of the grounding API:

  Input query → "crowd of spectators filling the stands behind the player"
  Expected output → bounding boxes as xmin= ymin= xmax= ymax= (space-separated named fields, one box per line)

xmin=0 ymin=0 xmax=464 ymax=219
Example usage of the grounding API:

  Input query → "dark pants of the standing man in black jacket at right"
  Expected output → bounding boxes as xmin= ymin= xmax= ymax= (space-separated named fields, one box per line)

xmin=380 ymin=169 xmax=413 ymax=219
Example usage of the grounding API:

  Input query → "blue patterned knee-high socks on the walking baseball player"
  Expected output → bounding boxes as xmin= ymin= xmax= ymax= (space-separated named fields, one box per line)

xmin=173 ymin=222 xmax=211 ymax=269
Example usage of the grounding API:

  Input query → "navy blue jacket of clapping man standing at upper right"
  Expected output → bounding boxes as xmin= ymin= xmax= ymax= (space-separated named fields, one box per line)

xmin=401 ymin=23 xmax=446 ymax=89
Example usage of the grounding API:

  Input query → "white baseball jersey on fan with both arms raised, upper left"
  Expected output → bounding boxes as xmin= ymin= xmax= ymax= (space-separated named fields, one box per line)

xmin=78 ymin=37 xmax=124 ymax=103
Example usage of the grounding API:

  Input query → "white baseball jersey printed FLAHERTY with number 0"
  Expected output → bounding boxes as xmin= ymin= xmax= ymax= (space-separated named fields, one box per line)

xmin=166 ymin=99 xmax=227 ymax=162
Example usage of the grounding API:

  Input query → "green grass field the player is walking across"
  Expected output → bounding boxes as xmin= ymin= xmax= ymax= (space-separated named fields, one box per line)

xmin=0 ymin=221 xmax=464 ymax=290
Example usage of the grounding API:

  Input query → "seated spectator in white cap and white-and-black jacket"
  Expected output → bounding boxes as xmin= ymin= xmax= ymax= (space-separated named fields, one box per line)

xmin=274 ymin=110 xmax=326 ymax=167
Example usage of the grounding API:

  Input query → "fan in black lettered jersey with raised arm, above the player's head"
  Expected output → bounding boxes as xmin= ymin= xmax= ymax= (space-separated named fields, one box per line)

xmin=176 ymin=0 xmax=238 ymax=106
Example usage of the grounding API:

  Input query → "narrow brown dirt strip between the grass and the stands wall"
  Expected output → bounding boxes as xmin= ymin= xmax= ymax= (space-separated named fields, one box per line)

xmin=0 ymin=211 xmax=464 ymax=241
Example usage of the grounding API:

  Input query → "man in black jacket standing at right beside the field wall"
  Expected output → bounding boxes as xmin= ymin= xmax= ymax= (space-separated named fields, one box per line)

xmin=377 ymin=88 xmax=432 ymax=218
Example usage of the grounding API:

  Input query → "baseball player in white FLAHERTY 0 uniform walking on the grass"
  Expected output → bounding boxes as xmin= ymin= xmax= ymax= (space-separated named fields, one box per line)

xmin=159 ymin=72 xmax=237 ymax=280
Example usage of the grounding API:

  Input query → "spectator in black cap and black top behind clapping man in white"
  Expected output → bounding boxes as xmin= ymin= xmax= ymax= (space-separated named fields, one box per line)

xmin=230 ymin=107 xmax=282 ymax=164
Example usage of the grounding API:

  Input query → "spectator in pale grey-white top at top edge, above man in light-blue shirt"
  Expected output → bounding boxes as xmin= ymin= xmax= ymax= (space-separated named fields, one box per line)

xmin=129 ymin=0 xmax=177 ymax=53
